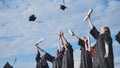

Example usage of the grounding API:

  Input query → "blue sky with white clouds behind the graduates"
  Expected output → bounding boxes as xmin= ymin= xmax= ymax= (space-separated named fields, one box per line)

xmin=0 ymin=0 xmax=120 ymax=68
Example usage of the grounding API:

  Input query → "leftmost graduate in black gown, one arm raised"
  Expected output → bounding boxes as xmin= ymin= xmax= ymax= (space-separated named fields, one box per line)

xmin=36 ymin=47 xmax=49 ymax=68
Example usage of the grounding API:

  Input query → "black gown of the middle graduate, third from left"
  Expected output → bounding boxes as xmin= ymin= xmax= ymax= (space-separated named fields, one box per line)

xmin=62 ymin=43 xmax=74 ymax=68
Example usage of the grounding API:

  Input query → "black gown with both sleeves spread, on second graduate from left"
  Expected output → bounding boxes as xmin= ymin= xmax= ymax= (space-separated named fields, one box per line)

xmin=45 ymin=47 xmax=65 ymax=68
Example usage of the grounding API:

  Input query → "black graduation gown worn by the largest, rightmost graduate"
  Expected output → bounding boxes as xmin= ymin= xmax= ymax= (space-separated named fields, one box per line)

xmin=90 ymin=27 xmax=114 ymax=68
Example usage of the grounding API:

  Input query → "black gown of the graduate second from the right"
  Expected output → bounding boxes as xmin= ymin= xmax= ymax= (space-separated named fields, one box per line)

xmin=78 ymin=39 xmax=92 ymax=68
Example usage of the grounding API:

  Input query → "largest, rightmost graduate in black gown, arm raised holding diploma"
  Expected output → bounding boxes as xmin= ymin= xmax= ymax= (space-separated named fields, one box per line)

xmin=88 ymin=16 xmax=114 ymax=68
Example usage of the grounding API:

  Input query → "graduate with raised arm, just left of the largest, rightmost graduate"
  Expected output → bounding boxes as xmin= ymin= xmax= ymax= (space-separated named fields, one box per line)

xmin=72 ymin=31 xmax=92 ymax=68
